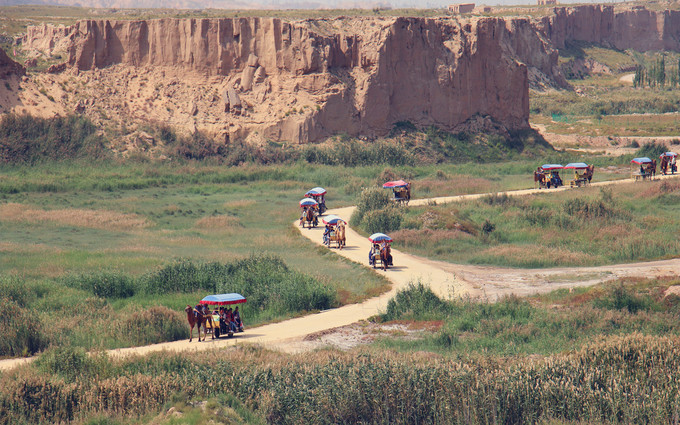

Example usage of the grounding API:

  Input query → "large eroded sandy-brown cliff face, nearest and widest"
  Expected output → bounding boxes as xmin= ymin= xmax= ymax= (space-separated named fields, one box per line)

xmin=24 ymin=18 xmax=560 ymax=143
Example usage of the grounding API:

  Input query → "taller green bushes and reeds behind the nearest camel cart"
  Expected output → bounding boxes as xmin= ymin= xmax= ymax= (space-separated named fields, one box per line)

xmin=0 ymin=256 xmax=336 ymax=357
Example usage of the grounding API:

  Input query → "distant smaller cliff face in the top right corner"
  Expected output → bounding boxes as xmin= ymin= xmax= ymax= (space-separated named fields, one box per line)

xmin=537 ymin=5 xmax=680 ymax=52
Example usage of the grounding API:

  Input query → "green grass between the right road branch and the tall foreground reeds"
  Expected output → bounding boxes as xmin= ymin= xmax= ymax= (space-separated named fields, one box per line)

xmin=375 ymin=277 xmax=680 ymax=358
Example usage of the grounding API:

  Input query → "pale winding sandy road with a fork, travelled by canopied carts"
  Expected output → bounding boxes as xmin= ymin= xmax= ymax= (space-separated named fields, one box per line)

xmin=0 ymin=175 xmax=680 ymax=370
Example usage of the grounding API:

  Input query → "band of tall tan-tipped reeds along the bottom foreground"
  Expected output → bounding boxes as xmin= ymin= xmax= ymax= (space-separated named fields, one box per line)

xmin=0 ymin=334 xmax=680 ymax=424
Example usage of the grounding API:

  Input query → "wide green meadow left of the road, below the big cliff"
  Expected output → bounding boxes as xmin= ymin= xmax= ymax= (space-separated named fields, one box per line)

xmin=0 ymin=147 xmax=636 ymax=356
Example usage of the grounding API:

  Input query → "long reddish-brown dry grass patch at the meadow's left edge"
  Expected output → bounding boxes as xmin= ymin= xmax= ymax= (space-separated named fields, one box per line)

xmin=0 ymin=203 xmax=150 ymax=230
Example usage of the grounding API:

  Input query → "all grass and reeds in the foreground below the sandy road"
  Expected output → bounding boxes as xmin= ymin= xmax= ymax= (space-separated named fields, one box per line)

xmin=0 ymin=278 xmax=680 ymax=425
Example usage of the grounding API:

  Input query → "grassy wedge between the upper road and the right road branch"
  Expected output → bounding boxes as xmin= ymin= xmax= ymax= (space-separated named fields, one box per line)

xmin=391 ymin=180 xmax=680 ymax=268
